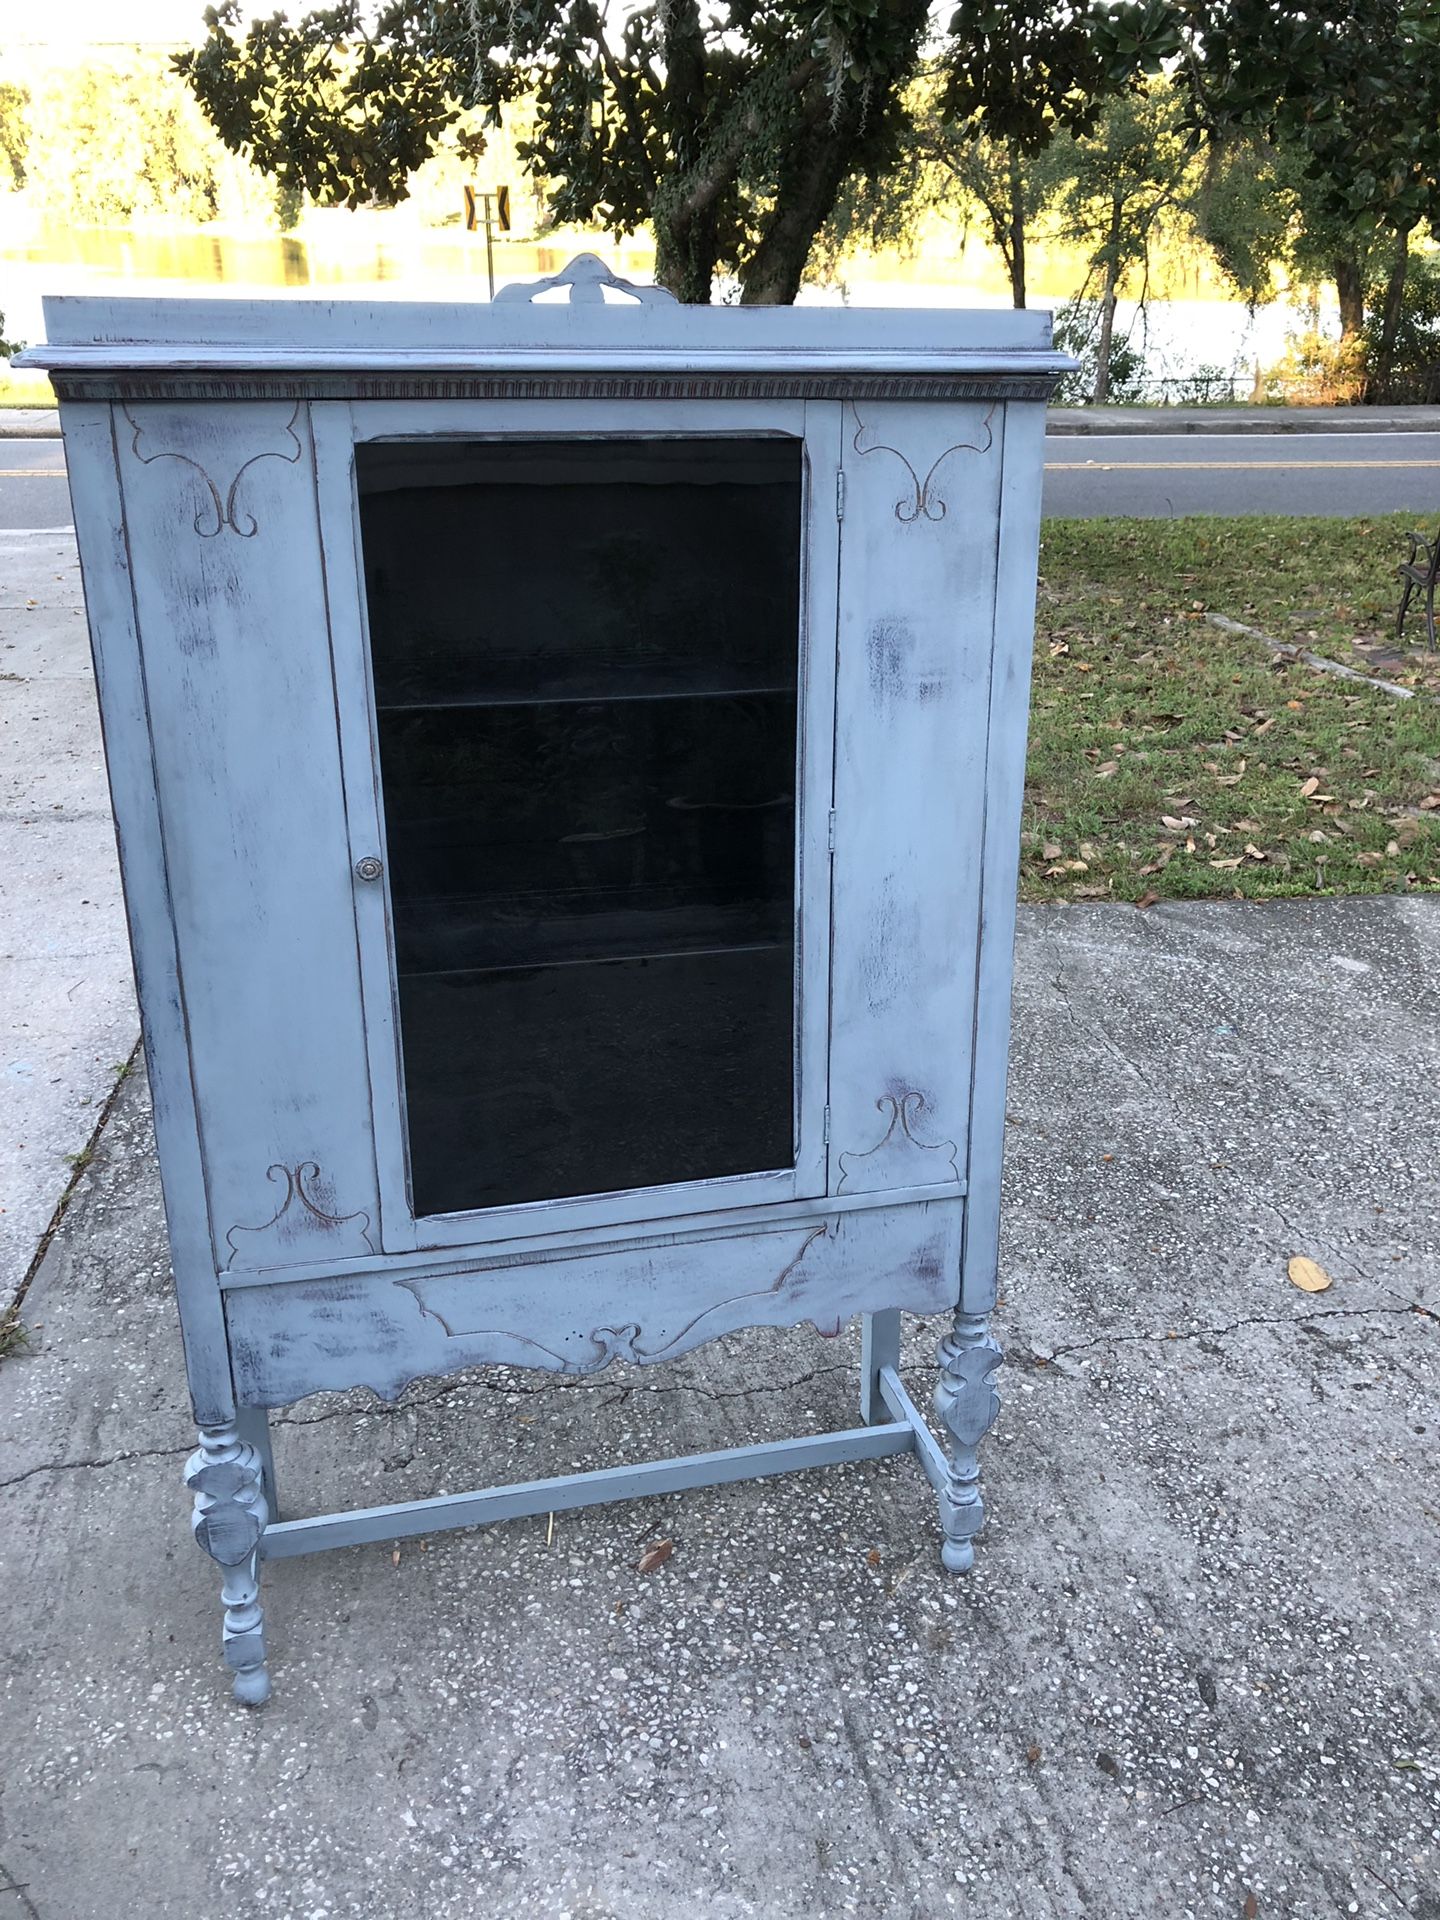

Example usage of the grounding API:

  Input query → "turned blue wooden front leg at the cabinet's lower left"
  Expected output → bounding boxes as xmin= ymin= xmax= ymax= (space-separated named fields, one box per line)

xmin=184 ymin=1421 xmax=271 ymax=1707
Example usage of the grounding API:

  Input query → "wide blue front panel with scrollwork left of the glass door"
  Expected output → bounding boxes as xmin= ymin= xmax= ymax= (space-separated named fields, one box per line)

xmin=115 ymin=401 xmax=378 ymax=1269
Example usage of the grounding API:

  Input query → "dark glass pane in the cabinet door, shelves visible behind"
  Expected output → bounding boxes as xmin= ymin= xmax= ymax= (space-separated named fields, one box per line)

xmin=355 ymin=440 xmax=801 ymax=1213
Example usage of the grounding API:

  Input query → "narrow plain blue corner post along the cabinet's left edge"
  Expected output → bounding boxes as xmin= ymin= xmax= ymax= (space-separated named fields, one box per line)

xmin=60 ymin=403 xmax=232 ymax=1427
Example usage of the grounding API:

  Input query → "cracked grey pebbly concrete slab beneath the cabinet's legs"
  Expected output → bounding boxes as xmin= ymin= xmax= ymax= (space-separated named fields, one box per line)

xmin=0 ymin=899 xmax=1440 ymax=1920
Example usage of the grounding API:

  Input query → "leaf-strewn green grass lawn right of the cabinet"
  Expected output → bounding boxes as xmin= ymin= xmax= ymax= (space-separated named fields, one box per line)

xmin=1021 ymin=515 xmax=1440 ymax=900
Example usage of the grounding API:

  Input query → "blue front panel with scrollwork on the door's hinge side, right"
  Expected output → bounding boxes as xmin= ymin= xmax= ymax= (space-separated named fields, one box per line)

xmin=829 ymin=401 xmax=1004 ymax=1192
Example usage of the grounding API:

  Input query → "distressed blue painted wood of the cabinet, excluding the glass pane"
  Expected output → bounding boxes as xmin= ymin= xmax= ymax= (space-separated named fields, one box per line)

xmin=29 ymin=273 xmax=1064 ymax=1705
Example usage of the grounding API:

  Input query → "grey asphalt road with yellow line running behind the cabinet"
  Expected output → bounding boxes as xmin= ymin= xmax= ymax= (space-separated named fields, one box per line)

xmin=0 ymin=434 xmax=1440 ymax=528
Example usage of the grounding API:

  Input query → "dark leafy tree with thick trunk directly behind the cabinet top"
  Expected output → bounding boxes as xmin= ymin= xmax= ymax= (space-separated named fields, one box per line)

xmin=177 ymin=0 xmax=929 ymax=301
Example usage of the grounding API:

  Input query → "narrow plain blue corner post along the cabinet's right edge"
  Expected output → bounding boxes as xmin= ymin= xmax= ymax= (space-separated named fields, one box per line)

xmin=960 ymin=403 xmax=1044 ymax=1313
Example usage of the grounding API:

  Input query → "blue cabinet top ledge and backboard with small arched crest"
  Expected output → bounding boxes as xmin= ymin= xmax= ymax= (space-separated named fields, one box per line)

xmin=17 ymin=255 xmax=1069 ymax=384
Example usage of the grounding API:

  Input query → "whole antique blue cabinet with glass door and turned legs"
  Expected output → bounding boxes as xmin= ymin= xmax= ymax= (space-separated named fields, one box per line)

xmin=31 ymin=255 xmax=1066 ymax=1703
